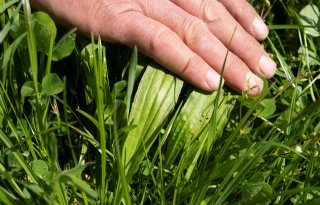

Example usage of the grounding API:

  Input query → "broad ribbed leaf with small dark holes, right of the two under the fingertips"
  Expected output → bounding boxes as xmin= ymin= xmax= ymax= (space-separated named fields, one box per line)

xmin=165 ymin=91 xmax=233 ymax=167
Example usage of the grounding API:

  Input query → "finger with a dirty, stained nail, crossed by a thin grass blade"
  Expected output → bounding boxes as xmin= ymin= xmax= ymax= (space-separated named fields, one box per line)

xmin=141 ymin=1 xmax=263 ymax=95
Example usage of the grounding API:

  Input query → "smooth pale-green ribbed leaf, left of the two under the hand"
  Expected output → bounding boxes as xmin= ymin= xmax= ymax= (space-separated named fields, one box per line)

xmin=122 ymin=66 xmax=183 ymax=181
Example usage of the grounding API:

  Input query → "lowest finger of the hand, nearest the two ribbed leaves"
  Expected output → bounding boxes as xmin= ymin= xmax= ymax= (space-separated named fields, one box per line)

xmin=121 ymin=13 xmax=220 ymax=91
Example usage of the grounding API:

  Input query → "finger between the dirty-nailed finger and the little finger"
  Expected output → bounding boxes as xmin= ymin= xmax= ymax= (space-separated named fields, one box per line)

xmin=206 ymin=0 xmax=276 ymax=78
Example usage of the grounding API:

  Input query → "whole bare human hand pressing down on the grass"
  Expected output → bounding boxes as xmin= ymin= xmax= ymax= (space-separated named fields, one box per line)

xmin=30 ymin=0 xmax=276 ymax=96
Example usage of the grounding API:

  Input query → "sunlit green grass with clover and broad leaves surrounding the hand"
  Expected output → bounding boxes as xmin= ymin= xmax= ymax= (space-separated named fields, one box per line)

xmin=0 ymin=0 xmax=320 ymax=205
